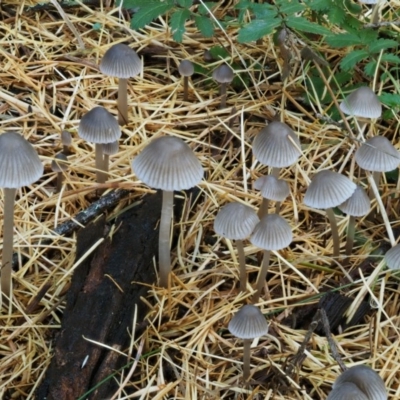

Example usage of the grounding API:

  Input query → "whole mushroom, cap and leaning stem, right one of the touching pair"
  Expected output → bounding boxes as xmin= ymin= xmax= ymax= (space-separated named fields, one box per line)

xmin=250 ymin=214 xmax=293 ymax=303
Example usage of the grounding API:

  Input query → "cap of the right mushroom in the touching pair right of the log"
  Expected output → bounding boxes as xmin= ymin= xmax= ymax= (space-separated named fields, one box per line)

xmin=250 ymin=214 xmax=293 ymax=250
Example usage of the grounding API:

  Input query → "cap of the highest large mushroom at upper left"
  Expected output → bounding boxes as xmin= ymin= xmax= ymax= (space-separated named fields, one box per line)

xmin=100 ymin=43 xmax=142 ymax=79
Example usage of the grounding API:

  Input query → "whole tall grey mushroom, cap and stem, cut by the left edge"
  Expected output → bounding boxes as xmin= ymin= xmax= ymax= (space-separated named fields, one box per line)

xmin=0 ymin=132 xmax=43 ymax=303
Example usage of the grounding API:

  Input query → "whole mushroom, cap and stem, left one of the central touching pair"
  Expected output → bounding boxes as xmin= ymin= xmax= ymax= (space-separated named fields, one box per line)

xmin=214 ymin=202 xmax=259 ymax=292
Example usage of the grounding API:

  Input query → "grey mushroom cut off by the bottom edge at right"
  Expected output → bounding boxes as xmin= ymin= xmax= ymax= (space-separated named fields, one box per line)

xmin=326 ymin=365 xmax=387 ymax=400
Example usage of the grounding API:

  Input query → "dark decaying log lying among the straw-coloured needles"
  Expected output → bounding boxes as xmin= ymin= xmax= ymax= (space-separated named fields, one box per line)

xmin=36 ymin=194 xmax=161 ymax=400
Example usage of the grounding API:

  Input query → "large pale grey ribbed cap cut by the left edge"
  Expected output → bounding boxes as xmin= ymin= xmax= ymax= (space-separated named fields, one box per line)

xmin=0 ymin=132 xmax=43 ymax=189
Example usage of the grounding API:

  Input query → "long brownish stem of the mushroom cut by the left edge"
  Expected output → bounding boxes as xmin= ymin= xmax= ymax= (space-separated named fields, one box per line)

xmin=0 ymin=188 xmax=17 ymax=305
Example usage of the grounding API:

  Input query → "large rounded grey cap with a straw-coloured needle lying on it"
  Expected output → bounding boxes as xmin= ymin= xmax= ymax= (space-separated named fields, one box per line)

xmin=253 ymin=121 xmax=300 ymax=168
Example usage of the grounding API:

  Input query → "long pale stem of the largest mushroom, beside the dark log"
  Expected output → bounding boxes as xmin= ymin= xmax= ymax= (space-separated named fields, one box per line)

xmin=158 ymin=190 xmax=174 ymax=288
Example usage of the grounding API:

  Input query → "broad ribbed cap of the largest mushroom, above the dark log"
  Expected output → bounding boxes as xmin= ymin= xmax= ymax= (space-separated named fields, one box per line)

xmin=132 ymin=136 xmax=204 ymax=191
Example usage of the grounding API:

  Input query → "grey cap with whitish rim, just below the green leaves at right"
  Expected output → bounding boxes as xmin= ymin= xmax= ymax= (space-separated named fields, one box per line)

xmin=339 ymin=86 xmax=382 ymax=119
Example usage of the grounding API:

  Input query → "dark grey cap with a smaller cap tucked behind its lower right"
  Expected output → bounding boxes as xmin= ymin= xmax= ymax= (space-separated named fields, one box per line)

xmin=78 ymin=107 xmax=121 ymax=143
